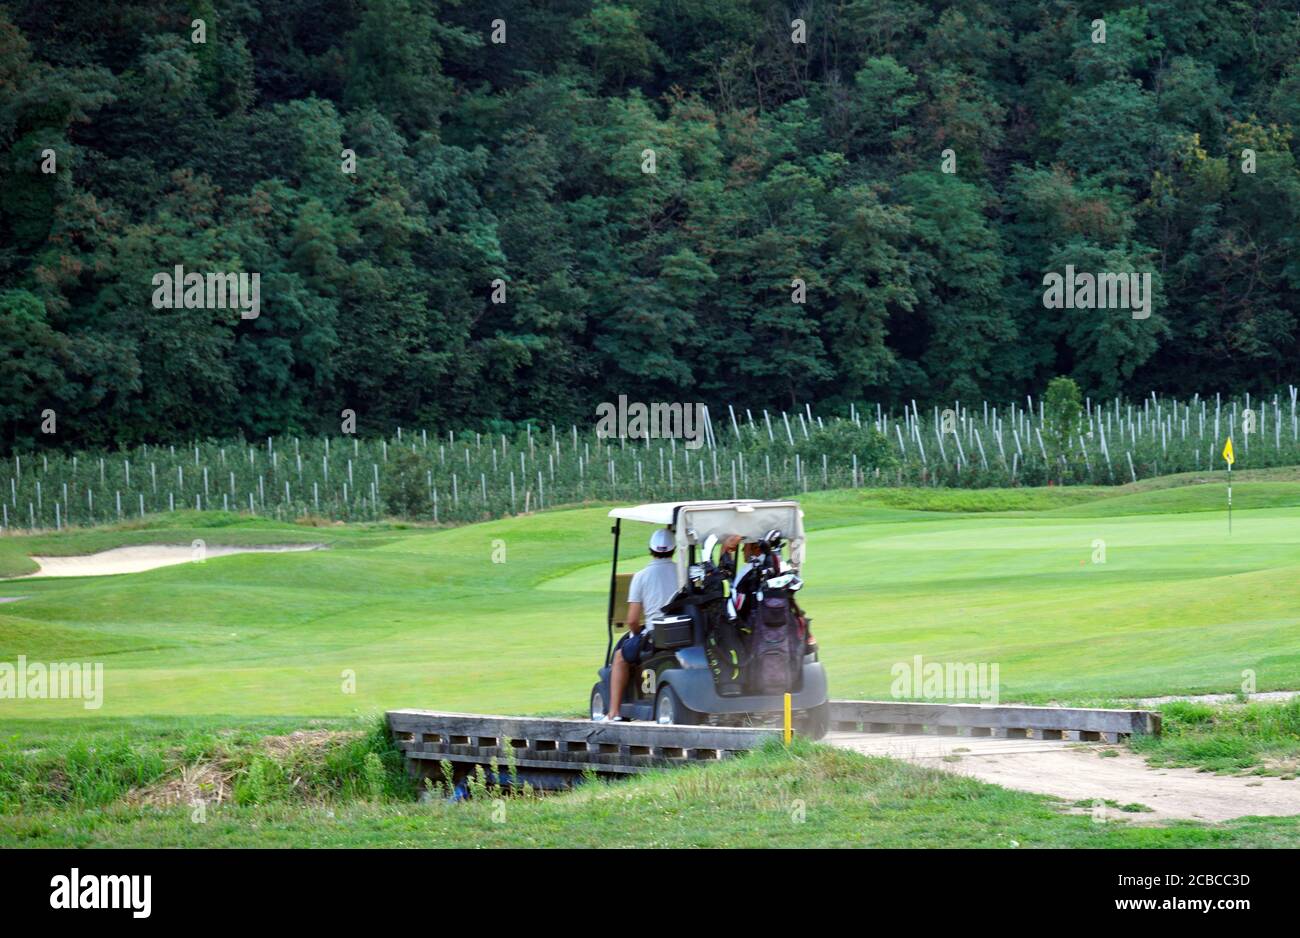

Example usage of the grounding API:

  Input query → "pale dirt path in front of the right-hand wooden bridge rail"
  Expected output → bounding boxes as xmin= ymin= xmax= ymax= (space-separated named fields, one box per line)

xmin=827 ymin=733 xmax=1300 ymax=822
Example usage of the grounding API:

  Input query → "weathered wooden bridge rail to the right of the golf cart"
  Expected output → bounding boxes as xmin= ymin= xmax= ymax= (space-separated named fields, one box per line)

xmin=831 ymin=700 xmax=1160 ymax=735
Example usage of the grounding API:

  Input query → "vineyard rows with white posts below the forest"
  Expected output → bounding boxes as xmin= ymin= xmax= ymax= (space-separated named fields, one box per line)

xmin=0 ymin=387 xmax=1300 ymax=531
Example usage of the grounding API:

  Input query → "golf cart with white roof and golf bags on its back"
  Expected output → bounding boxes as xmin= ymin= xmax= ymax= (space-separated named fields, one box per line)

xmin=590 ymin=499 xmax=829 ymax=739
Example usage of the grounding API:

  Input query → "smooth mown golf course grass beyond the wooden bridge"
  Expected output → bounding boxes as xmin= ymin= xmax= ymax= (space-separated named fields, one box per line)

xmin=0 ymin=482 xmax=1300 ymax=724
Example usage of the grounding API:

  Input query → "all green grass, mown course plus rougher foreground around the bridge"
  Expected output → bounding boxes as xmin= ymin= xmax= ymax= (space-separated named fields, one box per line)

xmin=0 ymin=474 xmax=1300 ymax=847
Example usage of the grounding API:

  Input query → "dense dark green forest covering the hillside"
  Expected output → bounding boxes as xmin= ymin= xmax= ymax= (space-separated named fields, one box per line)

xmin=0 ymin=0 xmax=1300 ymax=448
